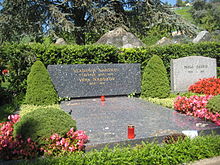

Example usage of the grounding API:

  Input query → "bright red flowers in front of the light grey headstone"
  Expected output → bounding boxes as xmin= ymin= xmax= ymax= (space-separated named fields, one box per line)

xmin=189 ymin=78 xmax=220 ymax=95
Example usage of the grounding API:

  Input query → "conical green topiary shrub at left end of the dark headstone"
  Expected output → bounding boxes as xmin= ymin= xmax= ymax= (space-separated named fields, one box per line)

xmin=25 ymin=61 xmax=58 ymax=105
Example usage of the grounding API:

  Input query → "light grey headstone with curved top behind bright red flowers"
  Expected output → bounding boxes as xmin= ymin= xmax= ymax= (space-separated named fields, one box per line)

xmin=170 ymin=56 xmax=217 ymax=92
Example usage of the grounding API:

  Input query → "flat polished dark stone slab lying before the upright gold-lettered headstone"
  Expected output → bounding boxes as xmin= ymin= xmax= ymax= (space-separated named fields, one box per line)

xmin=61 ymin=97 xmax=220 ymax=150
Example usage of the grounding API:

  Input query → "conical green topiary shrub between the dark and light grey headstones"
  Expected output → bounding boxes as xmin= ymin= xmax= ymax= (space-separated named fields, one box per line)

xmin=141 ymin=55 xmax=170 ymax=98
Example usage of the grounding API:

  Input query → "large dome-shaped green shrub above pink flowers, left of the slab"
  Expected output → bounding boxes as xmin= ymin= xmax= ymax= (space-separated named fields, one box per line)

xmin=13 ymin=108 xmax=76 ymax=144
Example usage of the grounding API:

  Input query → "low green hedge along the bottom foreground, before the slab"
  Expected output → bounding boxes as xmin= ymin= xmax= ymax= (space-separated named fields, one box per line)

xmin=16 ymin=136 xmax=220 ymax=165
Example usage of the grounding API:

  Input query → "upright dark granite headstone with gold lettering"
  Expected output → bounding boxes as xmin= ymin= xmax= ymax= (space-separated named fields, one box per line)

xmin=48 ymin=64 xmax=141 ymax=98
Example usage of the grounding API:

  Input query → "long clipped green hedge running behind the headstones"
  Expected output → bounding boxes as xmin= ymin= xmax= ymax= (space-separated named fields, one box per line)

xmin=0 ymin=42 xmax=220 ymax=92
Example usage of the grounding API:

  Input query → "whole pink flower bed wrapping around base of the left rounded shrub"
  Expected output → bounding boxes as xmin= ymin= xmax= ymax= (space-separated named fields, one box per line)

xmin=0 ymin=115 xmax=88 ymax=160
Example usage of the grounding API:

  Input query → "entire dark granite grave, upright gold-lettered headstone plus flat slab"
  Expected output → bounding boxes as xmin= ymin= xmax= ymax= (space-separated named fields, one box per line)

xmin=48 ymin=64 xmax=220 ymax=151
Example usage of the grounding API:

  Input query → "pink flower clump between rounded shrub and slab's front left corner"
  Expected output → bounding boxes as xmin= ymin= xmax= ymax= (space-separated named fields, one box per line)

xmin=43 ymin=128 xmax=88 ymax=156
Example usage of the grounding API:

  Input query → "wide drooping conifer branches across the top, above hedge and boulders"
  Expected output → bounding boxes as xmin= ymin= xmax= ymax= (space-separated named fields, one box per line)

xmin=0 ymin=0 xmax=198 ymax=44
